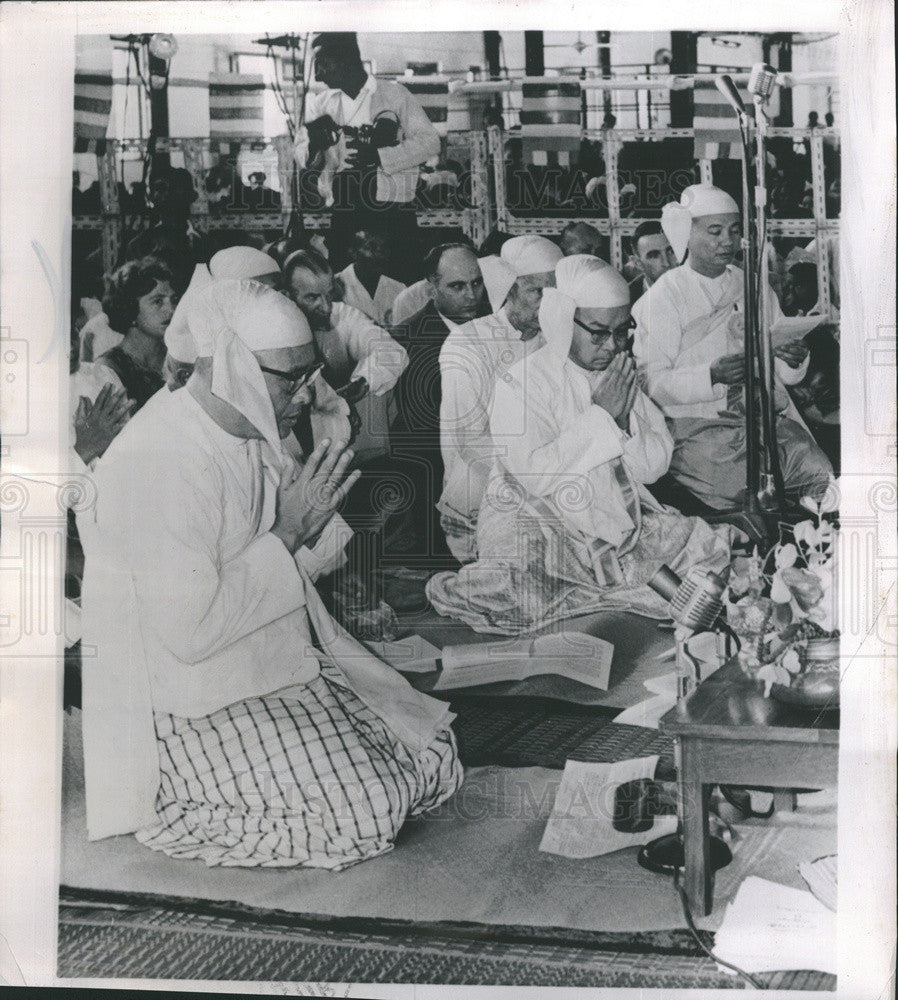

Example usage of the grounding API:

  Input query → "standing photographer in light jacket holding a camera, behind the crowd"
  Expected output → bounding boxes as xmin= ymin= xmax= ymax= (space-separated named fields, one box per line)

xmin=294 ymin=32 xmax=440 ymax=281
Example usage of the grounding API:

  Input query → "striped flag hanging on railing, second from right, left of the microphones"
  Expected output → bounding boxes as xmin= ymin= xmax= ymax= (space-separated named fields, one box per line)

xmin=521 ymin=83 xmax=583 ymax=167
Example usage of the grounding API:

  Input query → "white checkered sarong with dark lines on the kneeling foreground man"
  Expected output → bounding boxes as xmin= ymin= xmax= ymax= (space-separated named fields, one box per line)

xmin=136 ymin=665 xmax=462 ymax=871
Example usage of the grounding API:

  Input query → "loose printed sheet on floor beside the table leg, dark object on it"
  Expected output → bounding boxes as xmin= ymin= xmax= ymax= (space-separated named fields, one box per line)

xmin=539 ymin=755 xmax=677 ymax=864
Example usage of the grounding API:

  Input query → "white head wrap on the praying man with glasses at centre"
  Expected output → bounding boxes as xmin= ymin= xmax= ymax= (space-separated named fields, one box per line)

xmin=539 ymin=253 xmax=630 ymax=358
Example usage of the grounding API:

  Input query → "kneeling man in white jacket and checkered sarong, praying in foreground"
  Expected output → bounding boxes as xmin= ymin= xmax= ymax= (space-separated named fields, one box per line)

xmin=83 ymin=283 xmax=461 ymax=870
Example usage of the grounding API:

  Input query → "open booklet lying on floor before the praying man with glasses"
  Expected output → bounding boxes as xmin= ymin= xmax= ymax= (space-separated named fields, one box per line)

xmin=434 ymin=632 xmax=614 ymax=691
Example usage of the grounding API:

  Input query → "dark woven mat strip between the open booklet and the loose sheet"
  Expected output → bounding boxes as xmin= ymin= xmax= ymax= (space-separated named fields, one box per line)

xmin=449 ymin=695 xmax=676 ymax=779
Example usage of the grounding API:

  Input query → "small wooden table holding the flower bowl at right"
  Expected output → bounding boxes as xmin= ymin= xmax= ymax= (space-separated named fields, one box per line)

xmin=660 ymin=658 xmax=839 ymax=914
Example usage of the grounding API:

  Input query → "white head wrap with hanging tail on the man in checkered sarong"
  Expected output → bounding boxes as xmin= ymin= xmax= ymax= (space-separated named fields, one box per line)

xmin=187 ymin=280 xmax=312 ymax=460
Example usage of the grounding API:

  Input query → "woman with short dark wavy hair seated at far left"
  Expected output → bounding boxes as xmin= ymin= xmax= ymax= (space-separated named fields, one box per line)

xmin=94 ymin=257 xmax=177 ymax=410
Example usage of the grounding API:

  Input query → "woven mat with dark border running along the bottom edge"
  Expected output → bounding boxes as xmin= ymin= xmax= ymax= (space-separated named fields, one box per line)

xmin=57 ymin=887 xmax=835 ymax=990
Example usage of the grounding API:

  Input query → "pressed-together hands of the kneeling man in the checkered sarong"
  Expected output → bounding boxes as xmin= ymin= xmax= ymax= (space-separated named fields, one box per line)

xmin=271 ymin=438 xmax=361 ymax=555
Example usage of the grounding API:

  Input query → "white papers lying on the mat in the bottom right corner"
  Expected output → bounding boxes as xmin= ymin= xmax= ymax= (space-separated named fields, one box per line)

xmin=714 ymin=875 xmax=836 ymax=975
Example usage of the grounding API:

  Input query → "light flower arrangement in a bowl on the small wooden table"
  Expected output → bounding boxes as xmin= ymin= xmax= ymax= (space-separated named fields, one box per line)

xmin=726 ymin=497 xmax=839 ymax=697
